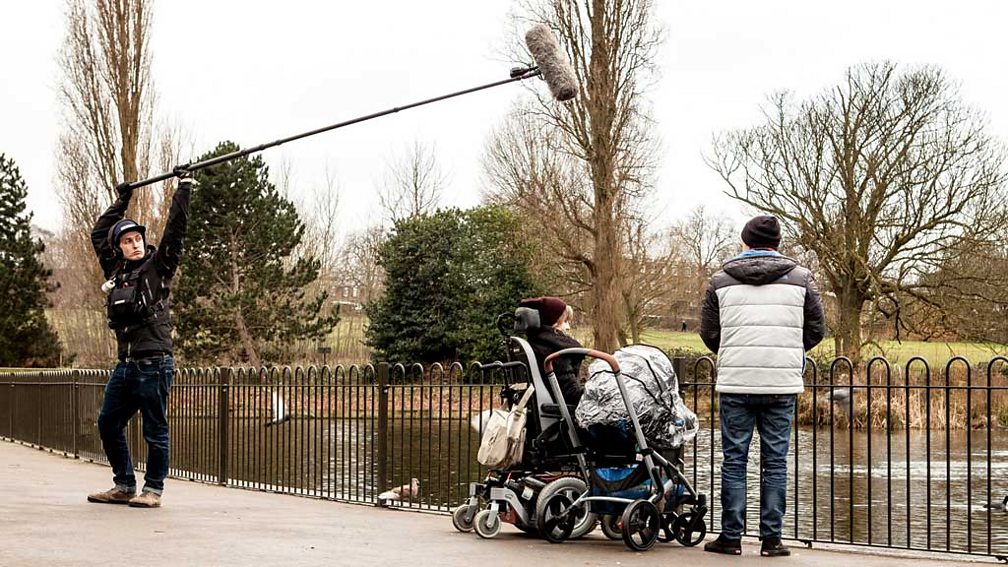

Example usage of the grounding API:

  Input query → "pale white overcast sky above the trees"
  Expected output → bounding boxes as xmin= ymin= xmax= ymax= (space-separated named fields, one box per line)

xmin=0 ymin=0 xmax=1008 ymax=230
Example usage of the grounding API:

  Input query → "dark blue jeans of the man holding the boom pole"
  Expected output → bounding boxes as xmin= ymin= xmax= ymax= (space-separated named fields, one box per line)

xmin=98 ymin=355 xmax=175 ymax=494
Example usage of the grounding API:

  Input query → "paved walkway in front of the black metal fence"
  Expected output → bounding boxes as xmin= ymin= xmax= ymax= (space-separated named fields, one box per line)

xmin=0 ymin=441 xmax=994 ymax=567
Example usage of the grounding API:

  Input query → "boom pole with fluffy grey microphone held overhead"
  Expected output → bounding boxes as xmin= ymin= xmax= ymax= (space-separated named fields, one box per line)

xmin=126 ymin=23 xmax=578 ymax=189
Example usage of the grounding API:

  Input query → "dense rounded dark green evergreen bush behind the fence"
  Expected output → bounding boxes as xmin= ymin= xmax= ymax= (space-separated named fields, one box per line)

xmin=365 ymin=207 xmax=538 ymax=363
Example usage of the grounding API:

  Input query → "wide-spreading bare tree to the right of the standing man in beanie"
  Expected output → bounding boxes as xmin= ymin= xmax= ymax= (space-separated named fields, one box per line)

xmin=709 ymin=63 xmax=1005 ymax=357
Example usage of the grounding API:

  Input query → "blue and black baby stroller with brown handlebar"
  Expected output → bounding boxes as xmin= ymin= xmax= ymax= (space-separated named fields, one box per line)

xmin=538 ymin=349 xmax=707 ymax=551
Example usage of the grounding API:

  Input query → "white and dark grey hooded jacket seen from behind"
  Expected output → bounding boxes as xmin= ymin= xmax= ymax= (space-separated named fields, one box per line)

xmin=700 ymin=250 xmax=826 ymax=393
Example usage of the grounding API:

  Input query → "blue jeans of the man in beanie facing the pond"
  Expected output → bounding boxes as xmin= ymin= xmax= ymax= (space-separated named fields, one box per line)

xmin=720 ymin=393 xmax=796 ymax=540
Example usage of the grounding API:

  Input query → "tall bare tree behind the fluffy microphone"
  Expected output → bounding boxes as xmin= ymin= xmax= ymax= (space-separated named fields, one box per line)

xmin=486 ymin=0 xmax=661 ymax=351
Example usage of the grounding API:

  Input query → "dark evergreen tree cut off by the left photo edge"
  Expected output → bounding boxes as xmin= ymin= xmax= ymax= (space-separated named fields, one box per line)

xmin=0 ymin=153 xmax=61 ymax=366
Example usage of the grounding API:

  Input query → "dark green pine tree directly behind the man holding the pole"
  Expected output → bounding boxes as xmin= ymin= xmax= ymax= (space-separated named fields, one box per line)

xmin=175 ymin=142 xmax=337 ymax=366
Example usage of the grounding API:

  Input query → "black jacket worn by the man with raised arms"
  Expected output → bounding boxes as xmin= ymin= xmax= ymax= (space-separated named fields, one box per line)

xmin=91 ymin=184 xmax=191 ymax=360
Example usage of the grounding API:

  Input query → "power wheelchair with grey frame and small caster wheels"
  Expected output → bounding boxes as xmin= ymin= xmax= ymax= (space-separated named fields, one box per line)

xmin=452 ymin=308 xmax=598 ymax=538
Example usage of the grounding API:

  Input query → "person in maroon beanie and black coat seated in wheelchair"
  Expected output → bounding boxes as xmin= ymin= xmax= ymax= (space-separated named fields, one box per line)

xmin=519 ymin=296 xmax=585 ymax=406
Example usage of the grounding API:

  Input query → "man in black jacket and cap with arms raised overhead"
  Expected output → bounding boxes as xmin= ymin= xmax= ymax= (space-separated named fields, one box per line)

xmin=88 ymin=169 xmax=197 ymax=507
